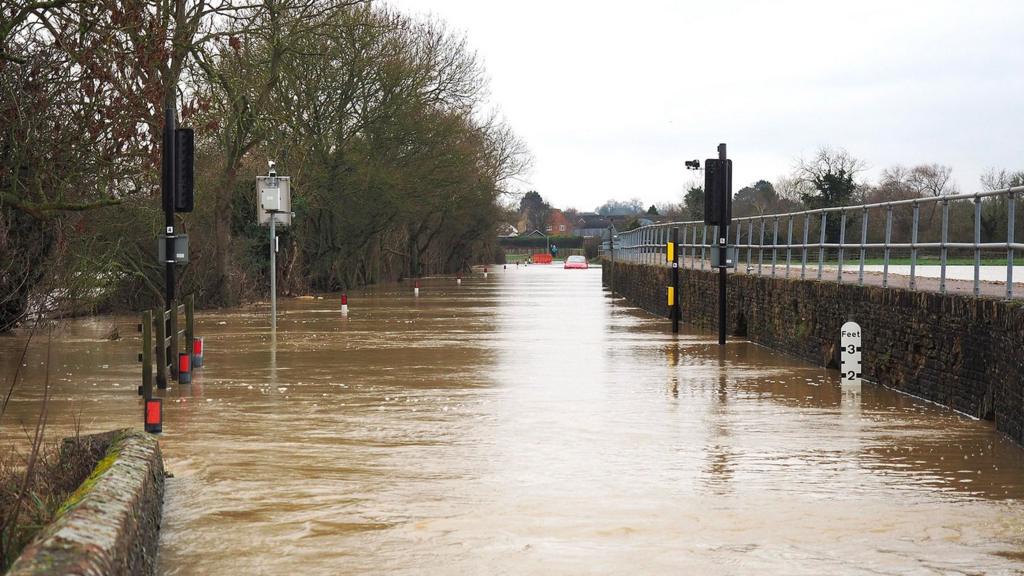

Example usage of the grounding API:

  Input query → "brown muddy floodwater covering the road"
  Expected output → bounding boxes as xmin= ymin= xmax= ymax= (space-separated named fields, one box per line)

xmin=0 ymin=266 xmax=1024 ymax=575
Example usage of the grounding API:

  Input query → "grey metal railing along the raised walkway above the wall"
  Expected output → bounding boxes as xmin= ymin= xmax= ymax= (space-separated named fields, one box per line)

xmin=605 ymin=187 xmax=1024 ymax=298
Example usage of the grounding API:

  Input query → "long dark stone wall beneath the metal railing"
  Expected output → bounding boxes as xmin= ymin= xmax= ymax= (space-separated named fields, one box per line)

xmin=602 ymin=262 xmax=1024 ymax=444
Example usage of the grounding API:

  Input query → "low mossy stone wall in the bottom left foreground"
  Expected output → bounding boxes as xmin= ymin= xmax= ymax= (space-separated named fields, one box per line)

xmin=7 ymin=430 xmax=164 ymax=576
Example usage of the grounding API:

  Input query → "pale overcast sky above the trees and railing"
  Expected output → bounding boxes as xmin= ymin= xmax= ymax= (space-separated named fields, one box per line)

xmin=390 ymin=0 xmax=1024 ymax=210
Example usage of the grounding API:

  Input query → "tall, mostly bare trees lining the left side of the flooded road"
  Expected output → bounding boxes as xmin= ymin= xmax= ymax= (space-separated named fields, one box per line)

xmin=0 ymin=0 xmax=528 ymax=331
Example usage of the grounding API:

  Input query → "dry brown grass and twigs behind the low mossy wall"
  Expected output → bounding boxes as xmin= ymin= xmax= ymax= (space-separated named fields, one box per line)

xmin=0 ymin=430 xmax=109 ymax=573
